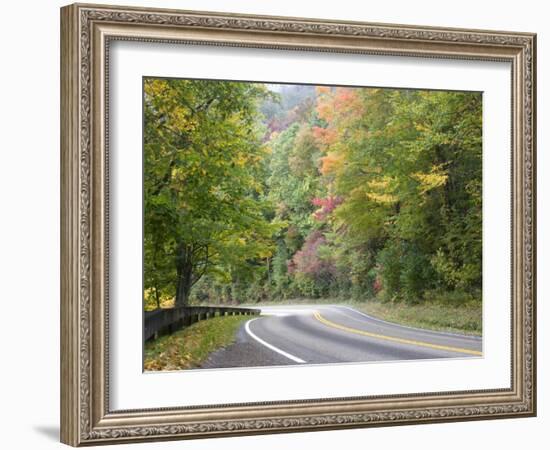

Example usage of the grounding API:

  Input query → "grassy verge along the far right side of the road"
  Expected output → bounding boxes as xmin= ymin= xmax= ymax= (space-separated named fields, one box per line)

xmin=248 ymin=298 xmax=482 ymax=336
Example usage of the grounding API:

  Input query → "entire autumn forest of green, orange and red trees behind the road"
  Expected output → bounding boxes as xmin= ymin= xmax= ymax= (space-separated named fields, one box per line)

xmin=143 ymin=78 xmax=482 ymax=316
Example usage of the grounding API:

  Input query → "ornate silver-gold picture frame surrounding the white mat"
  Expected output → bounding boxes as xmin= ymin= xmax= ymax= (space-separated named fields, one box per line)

xmin=60 ymin=4 xmax=536 ymax=446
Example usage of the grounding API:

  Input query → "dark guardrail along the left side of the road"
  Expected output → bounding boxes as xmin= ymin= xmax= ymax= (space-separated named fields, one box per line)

xmin=143 ymin=306 xmax=260 ymax=341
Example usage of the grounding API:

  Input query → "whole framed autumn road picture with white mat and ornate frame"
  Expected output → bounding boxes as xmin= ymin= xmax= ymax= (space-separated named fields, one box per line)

xmin=61 ymin=4 xmax=536 ymax=446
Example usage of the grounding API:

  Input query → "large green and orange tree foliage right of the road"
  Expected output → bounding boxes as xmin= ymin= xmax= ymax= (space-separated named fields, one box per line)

xmin=312 ymin=88 xmax=482 ymax=302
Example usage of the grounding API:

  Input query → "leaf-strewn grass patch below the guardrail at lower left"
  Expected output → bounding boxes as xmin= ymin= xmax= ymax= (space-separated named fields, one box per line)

xmin=144 ymin=316 xmax=250 ymax=371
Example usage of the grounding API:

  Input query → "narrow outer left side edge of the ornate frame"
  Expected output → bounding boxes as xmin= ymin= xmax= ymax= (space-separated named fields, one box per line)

xmin=60 ymin=3 xmax=80 ymax=445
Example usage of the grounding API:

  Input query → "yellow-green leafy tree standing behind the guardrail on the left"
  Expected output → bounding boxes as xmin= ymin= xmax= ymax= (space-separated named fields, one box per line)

xmin=144 ymin=79 xmax=277 ymax=303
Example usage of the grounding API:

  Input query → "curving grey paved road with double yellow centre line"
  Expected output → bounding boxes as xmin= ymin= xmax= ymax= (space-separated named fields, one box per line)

xmin=202 ymin=305 xmax=482 ymax=368
